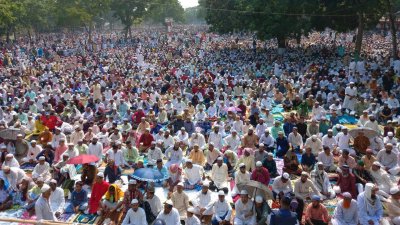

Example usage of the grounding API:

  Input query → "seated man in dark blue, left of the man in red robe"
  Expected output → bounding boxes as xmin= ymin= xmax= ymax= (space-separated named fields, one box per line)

xmin=65 ymin=181 xmax=88 ymax=213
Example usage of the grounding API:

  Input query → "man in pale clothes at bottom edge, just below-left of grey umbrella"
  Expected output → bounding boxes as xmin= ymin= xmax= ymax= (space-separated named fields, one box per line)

xmin=234 ymin=190 xmax=256 ymax=225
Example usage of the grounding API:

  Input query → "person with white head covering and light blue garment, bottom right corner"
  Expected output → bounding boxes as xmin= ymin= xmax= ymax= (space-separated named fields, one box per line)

xmin=357 ymin=183 xmax=383 ymax=225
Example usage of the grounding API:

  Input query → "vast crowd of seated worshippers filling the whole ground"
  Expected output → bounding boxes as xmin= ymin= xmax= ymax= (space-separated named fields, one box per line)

xmin=0 ymin=26 xmax=400 ymax=225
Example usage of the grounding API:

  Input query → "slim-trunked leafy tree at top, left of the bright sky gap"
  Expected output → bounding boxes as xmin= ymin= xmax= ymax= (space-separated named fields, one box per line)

xmin=111 ymin=0 xmax=151 ymax=37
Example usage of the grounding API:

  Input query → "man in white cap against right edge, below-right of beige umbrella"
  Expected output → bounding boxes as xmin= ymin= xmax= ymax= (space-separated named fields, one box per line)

xmin=376 ymin=143 xmax=400 ymax=175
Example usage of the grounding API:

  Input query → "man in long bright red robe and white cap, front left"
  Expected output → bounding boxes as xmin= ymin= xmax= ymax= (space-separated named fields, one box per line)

xmin=89 ymin=172 xmax=110 ymax=214
